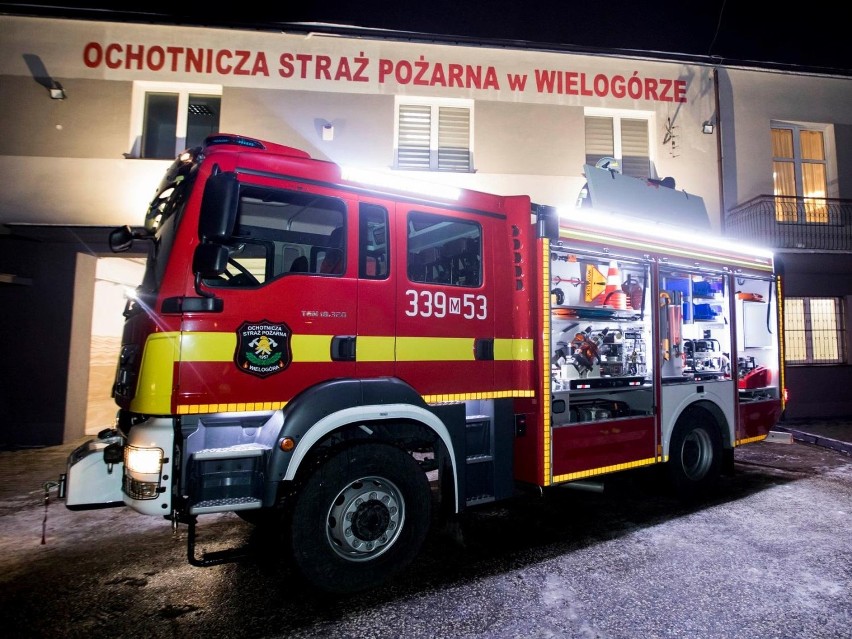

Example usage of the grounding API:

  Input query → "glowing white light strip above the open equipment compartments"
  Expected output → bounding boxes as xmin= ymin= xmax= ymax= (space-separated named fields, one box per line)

xmin=558 ymin=208 xmax=774 ymax=259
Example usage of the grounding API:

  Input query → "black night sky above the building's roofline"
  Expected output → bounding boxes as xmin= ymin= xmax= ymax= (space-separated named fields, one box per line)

xmin=5 ymin=0 xmax=852 ymax=75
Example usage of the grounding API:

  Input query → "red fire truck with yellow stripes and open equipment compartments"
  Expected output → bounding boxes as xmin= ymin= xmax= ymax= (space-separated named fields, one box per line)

xmin=61 ymin=134 xmax=784 ymax=592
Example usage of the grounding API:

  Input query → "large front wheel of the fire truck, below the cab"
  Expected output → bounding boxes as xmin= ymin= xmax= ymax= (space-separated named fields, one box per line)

xmin=291 ymin=444 xmax=431 ymax=594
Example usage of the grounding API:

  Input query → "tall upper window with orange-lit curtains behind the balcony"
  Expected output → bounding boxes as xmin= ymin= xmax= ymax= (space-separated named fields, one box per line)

xmin=772 ymin=124 xmax=829 ymax=224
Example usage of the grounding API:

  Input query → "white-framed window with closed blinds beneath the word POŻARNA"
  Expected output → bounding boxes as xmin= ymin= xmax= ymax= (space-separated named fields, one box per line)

xmin=394 ymin=99 xmax=473 ymax=173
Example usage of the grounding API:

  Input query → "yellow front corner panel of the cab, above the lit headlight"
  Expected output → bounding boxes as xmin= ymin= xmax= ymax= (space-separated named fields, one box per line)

xmin=130 ymin=333 xmax=180 ymax=415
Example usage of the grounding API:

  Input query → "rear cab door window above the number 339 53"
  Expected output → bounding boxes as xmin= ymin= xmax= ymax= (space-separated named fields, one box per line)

xmin=407 ymin=211 xmax=482 ymax=287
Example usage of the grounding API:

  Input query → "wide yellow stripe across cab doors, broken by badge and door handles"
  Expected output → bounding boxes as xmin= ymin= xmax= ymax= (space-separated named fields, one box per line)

xmin=175 ymin=332 xmax=533 ymax=362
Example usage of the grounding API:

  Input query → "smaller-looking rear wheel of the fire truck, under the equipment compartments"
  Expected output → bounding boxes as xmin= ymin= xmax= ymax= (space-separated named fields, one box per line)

xmin=666 ymin=410 xmax=722 ymax=500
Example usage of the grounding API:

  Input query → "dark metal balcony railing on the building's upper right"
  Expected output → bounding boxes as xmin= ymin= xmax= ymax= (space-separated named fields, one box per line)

xmin=724 ymin=195 xmax=852 ymax=251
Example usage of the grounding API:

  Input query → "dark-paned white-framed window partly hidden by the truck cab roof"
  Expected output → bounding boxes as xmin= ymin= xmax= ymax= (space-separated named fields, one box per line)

xmin=130 ymin=82 xmax=222 ymax=160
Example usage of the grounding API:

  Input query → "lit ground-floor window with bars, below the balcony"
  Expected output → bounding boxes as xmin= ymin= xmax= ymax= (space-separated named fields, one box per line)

xmin=784 ymin=297 xmax=846 ymax=364
